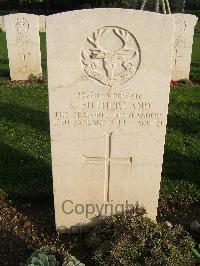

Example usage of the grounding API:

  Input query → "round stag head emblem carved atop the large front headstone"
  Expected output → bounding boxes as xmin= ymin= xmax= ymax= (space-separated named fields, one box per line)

xmin=81 ymin=27 xmax=140 ymax=87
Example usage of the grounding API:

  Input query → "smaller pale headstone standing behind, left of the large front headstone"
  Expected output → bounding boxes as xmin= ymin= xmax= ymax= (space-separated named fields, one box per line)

xmin=4 ymin=13 xmax=42 ymax=80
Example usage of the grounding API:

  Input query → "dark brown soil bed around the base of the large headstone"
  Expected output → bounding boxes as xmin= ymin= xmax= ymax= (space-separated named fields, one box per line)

xmin=0 ymin=195 xmax=200 ymax=266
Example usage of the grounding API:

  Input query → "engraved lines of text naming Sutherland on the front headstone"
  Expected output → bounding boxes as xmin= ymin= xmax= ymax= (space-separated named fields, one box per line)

xmin=53 ymin=92 xmax=163 ymax=128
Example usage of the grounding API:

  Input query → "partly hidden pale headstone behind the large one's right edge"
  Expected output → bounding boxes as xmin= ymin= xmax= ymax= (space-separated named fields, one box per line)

xmin=172 ymin=14 xmax=198 ymax=81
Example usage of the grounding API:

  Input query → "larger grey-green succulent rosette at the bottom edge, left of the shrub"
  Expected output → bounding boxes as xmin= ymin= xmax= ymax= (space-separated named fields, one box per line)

xmin=27 ymin=246 xmax=59 ymax=266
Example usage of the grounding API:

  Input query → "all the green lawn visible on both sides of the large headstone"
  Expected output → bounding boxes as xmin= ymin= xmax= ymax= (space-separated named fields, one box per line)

xmin=0 ymin=26 xmax=200 ymax=204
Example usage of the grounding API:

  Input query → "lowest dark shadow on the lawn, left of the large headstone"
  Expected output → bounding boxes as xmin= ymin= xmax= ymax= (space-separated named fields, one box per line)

xmin=0 ymin=142 xmax=53 ymax=200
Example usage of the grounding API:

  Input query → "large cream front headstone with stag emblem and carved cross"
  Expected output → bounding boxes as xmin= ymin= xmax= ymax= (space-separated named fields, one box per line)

xmin=47 ymin=9 xmax=174 ymax=230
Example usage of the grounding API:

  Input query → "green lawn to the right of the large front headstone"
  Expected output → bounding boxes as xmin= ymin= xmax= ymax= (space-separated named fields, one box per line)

xmin=161 ymin=87 xmax=200 ymax=198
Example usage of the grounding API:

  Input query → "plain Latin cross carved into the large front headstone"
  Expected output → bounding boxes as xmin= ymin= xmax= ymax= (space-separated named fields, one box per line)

xmin=83 ymin=132 xmax=132 ymax=202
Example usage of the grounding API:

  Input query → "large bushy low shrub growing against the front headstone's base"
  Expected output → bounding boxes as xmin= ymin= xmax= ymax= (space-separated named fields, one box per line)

xmin=87 ymin=206 xmax=195 ymax=266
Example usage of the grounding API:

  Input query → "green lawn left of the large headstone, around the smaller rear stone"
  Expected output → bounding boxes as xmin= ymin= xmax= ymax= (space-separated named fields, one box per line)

xmin=0 ymin=33 xmax=52 ymax=198
